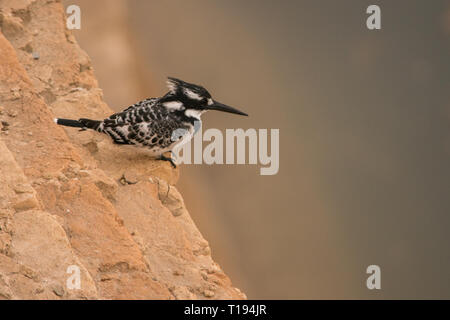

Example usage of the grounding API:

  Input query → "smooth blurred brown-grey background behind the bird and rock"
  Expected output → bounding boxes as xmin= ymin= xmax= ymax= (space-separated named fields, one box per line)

xmin=63 ymin=0 xmax=450 ymax=299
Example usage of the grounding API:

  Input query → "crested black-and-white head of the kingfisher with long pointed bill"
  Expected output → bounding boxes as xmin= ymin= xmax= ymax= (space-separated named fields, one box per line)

xmin=162 ymin=77 xmax=248 ymax=118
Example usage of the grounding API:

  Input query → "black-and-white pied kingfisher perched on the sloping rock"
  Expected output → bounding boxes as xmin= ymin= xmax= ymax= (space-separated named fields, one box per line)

xmin=54 ymin=77 xmax=248 ymax=168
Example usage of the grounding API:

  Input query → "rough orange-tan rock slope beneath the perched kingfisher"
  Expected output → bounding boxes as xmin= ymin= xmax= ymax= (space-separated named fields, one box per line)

xmin=0 ymin=0 xmax=245 ymax=299
